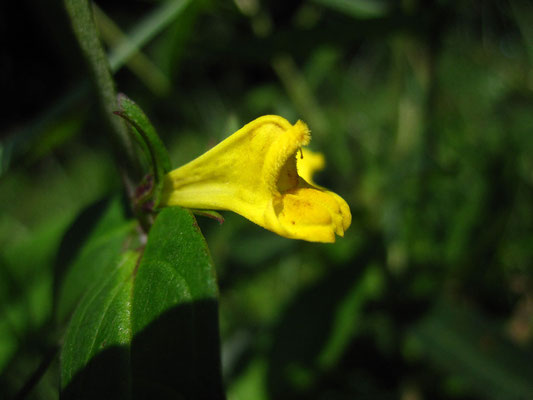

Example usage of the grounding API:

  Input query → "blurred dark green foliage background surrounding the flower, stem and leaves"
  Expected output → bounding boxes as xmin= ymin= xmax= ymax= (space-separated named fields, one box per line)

xmin=0 ymin=0 xmax=533 ymax=400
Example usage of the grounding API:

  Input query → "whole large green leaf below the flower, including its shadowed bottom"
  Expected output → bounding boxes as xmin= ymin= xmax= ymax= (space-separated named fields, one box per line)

xmin=61 ymin=208 xmax=224 ymax=399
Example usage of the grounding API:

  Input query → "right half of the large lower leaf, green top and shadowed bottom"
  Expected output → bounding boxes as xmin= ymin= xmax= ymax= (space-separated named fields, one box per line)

xmin=132 ymin=207 xmax=224 ymax=399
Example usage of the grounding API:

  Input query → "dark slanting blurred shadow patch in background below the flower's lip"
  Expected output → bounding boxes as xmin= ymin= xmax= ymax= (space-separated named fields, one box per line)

xmin=267 ymin=230 xmax=385 ymax=399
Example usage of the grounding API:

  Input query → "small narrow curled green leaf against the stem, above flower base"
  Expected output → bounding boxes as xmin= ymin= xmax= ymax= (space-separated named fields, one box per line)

xmin=115 ymin=93 xmax=171 ymax=207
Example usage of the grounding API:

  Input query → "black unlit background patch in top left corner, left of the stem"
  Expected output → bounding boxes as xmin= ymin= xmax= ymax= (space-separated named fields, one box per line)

xmin=0 ymin=0 xmax=84 ymax=138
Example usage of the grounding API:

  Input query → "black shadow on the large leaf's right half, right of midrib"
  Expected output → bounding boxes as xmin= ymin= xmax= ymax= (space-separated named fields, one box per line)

xmin=132 ymin=300 xmax=225 ymax=399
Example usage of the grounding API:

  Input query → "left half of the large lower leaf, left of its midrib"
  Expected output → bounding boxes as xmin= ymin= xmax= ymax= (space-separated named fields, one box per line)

xmin=61 ymin=252 xmax=139 ymax=399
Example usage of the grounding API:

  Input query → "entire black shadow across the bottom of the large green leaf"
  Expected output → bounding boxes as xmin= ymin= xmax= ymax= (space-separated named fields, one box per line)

xmin=61 ymin=300 xmax=225 ymax=400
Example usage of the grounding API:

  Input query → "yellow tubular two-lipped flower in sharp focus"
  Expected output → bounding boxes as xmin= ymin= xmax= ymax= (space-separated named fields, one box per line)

xmin=160 ymin=115 xmax=352 ymax=242
